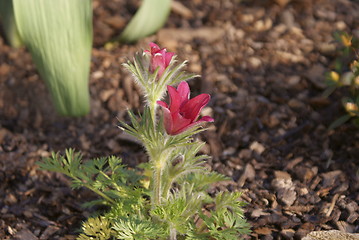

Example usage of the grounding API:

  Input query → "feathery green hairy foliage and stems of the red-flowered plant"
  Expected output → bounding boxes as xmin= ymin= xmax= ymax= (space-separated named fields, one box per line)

xmin=39 ymin=44 xmax=249 ymax=240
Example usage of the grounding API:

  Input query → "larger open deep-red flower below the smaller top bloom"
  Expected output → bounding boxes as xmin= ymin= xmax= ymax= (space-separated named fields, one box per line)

xmin=157 ymin=82 xmax=214 ymax=135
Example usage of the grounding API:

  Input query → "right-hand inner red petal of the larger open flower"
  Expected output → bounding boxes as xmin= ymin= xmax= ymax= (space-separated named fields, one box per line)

xmin=180 ymin=94 xmax=211 ymax=122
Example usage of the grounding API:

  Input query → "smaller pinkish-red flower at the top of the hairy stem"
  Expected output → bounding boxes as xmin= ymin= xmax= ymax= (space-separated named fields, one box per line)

xmin=145 ymin=42 xmax=174 ymax=77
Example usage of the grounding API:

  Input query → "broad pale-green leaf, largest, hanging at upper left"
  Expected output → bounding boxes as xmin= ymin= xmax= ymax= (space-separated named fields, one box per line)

xmin=14 ymin=0 xmax=92 ymax=116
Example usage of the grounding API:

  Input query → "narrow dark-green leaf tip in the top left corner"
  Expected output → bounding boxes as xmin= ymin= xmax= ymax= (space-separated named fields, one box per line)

xmin=0 ymin=0 xmax=22 ymax=48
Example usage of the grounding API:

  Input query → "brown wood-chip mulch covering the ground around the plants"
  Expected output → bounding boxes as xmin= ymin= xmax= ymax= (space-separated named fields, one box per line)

xmin=0 ymin=0 xmax=359 ymax=240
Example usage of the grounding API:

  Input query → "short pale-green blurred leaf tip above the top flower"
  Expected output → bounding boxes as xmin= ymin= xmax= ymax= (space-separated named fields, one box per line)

xmin=119 ymin=0 xmax=171 ymax=43
